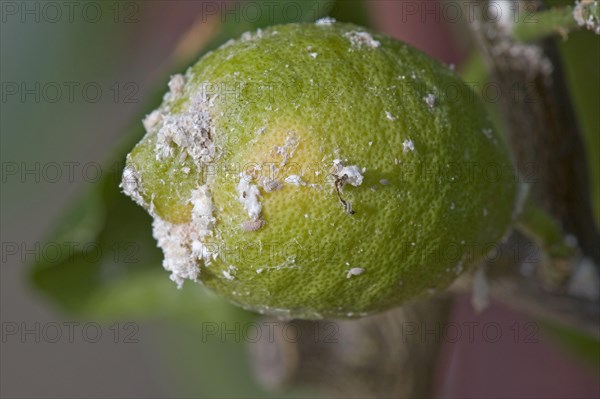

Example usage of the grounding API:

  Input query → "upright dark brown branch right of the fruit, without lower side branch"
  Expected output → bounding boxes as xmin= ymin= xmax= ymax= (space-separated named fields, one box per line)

xmin=471 ymin=1 xmax=600 ymax=264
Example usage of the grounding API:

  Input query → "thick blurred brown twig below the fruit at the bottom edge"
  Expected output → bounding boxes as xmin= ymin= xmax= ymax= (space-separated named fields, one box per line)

xmin=250 ymin=295 xmax=452 ymax=398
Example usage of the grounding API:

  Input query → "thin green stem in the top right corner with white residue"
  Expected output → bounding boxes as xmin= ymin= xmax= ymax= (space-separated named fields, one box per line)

xmin=510 ymin=0 xmax=600 ymax=42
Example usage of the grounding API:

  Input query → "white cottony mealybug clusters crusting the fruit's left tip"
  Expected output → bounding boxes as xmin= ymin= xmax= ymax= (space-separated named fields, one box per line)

xmin=134 ymin=75 xmax=223 ymax=288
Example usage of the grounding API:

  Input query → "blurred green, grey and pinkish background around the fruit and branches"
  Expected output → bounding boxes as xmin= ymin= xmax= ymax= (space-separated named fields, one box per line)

xmin=0 ymin=0 xmax=600 ymax=398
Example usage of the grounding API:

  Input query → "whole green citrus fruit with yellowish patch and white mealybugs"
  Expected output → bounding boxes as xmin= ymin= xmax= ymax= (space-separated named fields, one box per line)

xmin=122 ymin=20 xmax=516 ymax=319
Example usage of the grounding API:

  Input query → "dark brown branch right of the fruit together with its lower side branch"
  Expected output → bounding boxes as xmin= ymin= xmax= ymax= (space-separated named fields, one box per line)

xmin=471 ymin=1 xmax=600 ymax=336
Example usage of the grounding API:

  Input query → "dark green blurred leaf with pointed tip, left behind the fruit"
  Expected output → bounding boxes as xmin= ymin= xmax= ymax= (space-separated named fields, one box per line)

xmin=32 ymin=136 xmax=166 ymax=313
